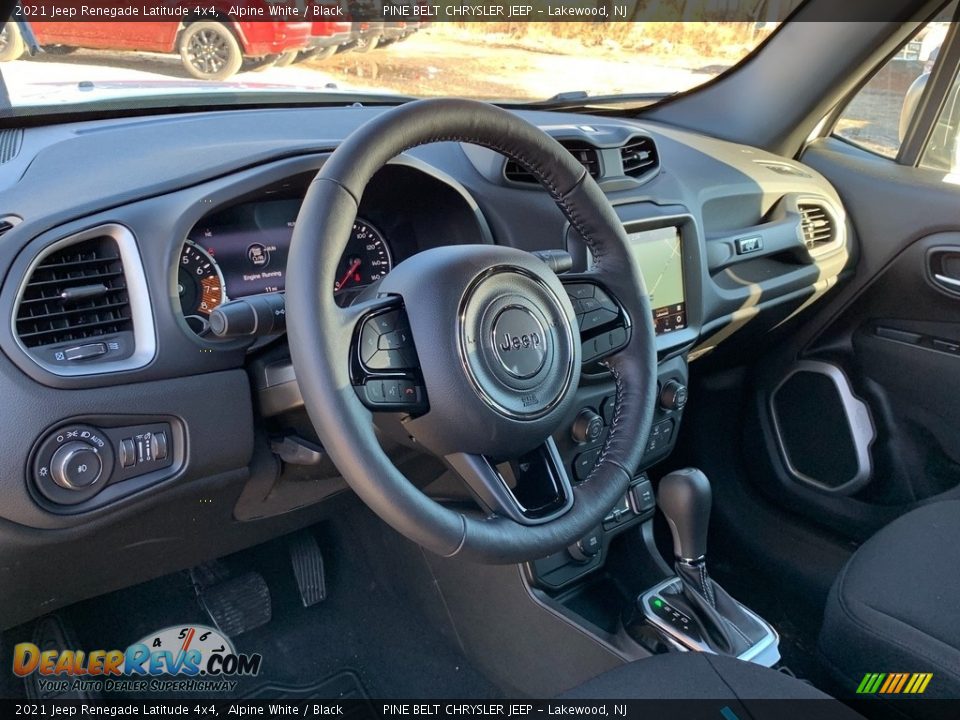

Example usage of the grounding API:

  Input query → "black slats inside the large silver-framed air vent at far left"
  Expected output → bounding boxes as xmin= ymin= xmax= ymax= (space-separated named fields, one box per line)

xmin=16 ymin=236 xmax=133 ymax=348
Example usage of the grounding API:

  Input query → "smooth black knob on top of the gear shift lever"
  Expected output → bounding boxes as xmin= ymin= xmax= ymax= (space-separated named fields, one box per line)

xmin=657 ymin=468 xmax=712 ymax=562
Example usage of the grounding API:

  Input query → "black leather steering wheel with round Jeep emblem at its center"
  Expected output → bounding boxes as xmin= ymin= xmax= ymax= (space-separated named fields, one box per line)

xmin=286 ymin=99 xmax=656 ymax=563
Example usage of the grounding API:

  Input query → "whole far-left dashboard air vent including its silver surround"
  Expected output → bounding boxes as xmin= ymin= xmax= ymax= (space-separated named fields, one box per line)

xmin=13 ymin=224 xmax=156 ymax=376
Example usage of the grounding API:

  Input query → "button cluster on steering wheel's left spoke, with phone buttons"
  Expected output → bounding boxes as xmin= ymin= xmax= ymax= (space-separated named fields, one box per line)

xmin=343 ymin=297 xmax=429 ymax=415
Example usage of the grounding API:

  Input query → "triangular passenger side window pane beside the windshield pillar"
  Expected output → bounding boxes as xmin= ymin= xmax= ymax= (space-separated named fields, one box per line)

xmin=833 ymin=1 xmax=957 ymax=160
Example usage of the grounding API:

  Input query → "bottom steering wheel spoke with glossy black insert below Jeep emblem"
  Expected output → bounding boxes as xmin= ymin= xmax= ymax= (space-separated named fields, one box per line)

xmin=445 ymin=438 xmax=573 ymax=525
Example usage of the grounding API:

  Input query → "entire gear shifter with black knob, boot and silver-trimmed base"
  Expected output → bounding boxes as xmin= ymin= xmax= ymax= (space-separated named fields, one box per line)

xmin=640 ymin=468 xmax=779 ymax=665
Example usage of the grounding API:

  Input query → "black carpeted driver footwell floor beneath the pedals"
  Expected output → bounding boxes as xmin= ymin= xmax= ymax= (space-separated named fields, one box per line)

xmin=3 ymin=518 xmax=501 ymax=700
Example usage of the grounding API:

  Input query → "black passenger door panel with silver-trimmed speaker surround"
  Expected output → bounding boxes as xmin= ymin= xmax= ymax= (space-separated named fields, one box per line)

xmin=746 ymin=139 xmax=960 ymax=539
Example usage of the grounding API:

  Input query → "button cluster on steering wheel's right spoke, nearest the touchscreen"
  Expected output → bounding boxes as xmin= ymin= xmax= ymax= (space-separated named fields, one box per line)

xmin=561 ymin=273 xmax=631 ymax=365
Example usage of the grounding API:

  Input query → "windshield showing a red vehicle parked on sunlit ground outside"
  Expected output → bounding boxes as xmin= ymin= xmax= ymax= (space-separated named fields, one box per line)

xmin=0 ymin=10 xmax=796 ymax=115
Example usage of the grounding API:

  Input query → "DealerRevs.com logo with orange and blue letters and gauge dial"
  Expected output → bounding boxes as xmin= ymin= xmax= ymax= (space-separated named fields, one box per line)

xmin=13 ymin=625 xmax=263 ymax=692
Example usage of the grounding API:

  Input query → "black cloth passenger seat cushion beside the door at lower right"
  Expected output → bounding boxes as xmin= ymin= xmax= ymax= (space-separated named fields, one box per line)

xmin=820 ymin=501 xmax=960 ymax=698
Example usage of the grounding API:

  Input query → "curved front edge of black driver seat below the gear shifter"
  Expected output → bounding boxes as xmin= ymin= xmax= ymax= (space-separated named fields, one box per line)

xmin=560 ymin=653 xmax=844 ymax=704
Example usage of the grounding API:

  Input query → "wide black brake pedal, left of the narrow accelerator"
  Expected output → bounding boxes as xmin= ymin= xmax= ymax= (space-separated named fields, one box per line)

xmin=190 ymin=563 xmax=273 ymax=638
